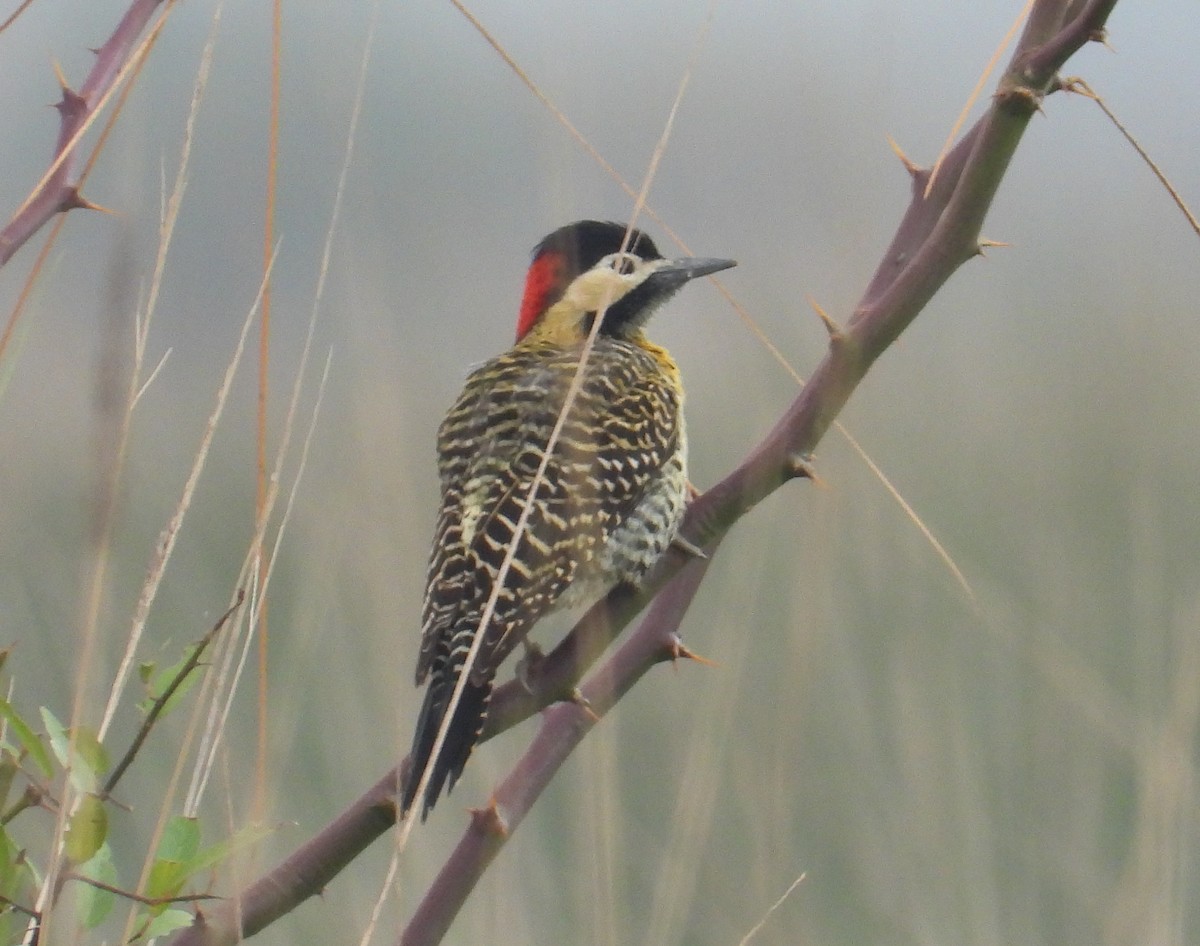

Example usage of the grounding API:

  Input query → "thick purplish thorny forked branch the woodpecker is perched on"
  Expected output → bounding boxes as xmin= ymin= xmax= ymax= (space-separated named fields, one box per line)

xmin=174 ymin=0 xmax=1116 ymax=946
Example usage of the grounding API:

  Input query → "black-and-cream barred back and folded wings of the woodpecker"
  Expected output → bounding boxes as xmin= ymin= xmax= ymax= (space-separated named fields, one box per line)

xmin=418 ymin=343 xmax=679 ymax=682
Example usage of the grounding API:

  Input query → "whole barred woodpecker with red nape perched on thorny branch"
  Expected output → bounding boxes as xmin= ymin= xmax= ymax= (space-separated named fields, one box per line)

xmin=401 ymin=220 xmax=736 ymax=820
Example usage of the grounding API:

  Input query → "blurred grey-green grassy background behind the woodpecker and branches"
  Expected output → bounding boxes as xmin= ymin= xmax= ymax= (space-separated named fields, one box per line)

xmin=0 ymin=0 xmax=1200 ymax=946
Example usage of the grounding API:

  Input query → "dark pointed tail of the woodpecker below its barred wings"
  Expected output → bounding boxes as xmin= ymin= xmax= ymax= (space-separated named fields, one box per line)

xmin=401 ymin=670 xmax=493 ymax=821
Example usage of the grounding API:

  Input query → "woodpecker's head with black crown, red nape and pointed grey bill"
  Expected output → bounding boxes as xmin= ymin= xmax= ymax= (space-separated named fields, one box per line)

xmin=517 ymin=220 xmax=737 ymax=341
